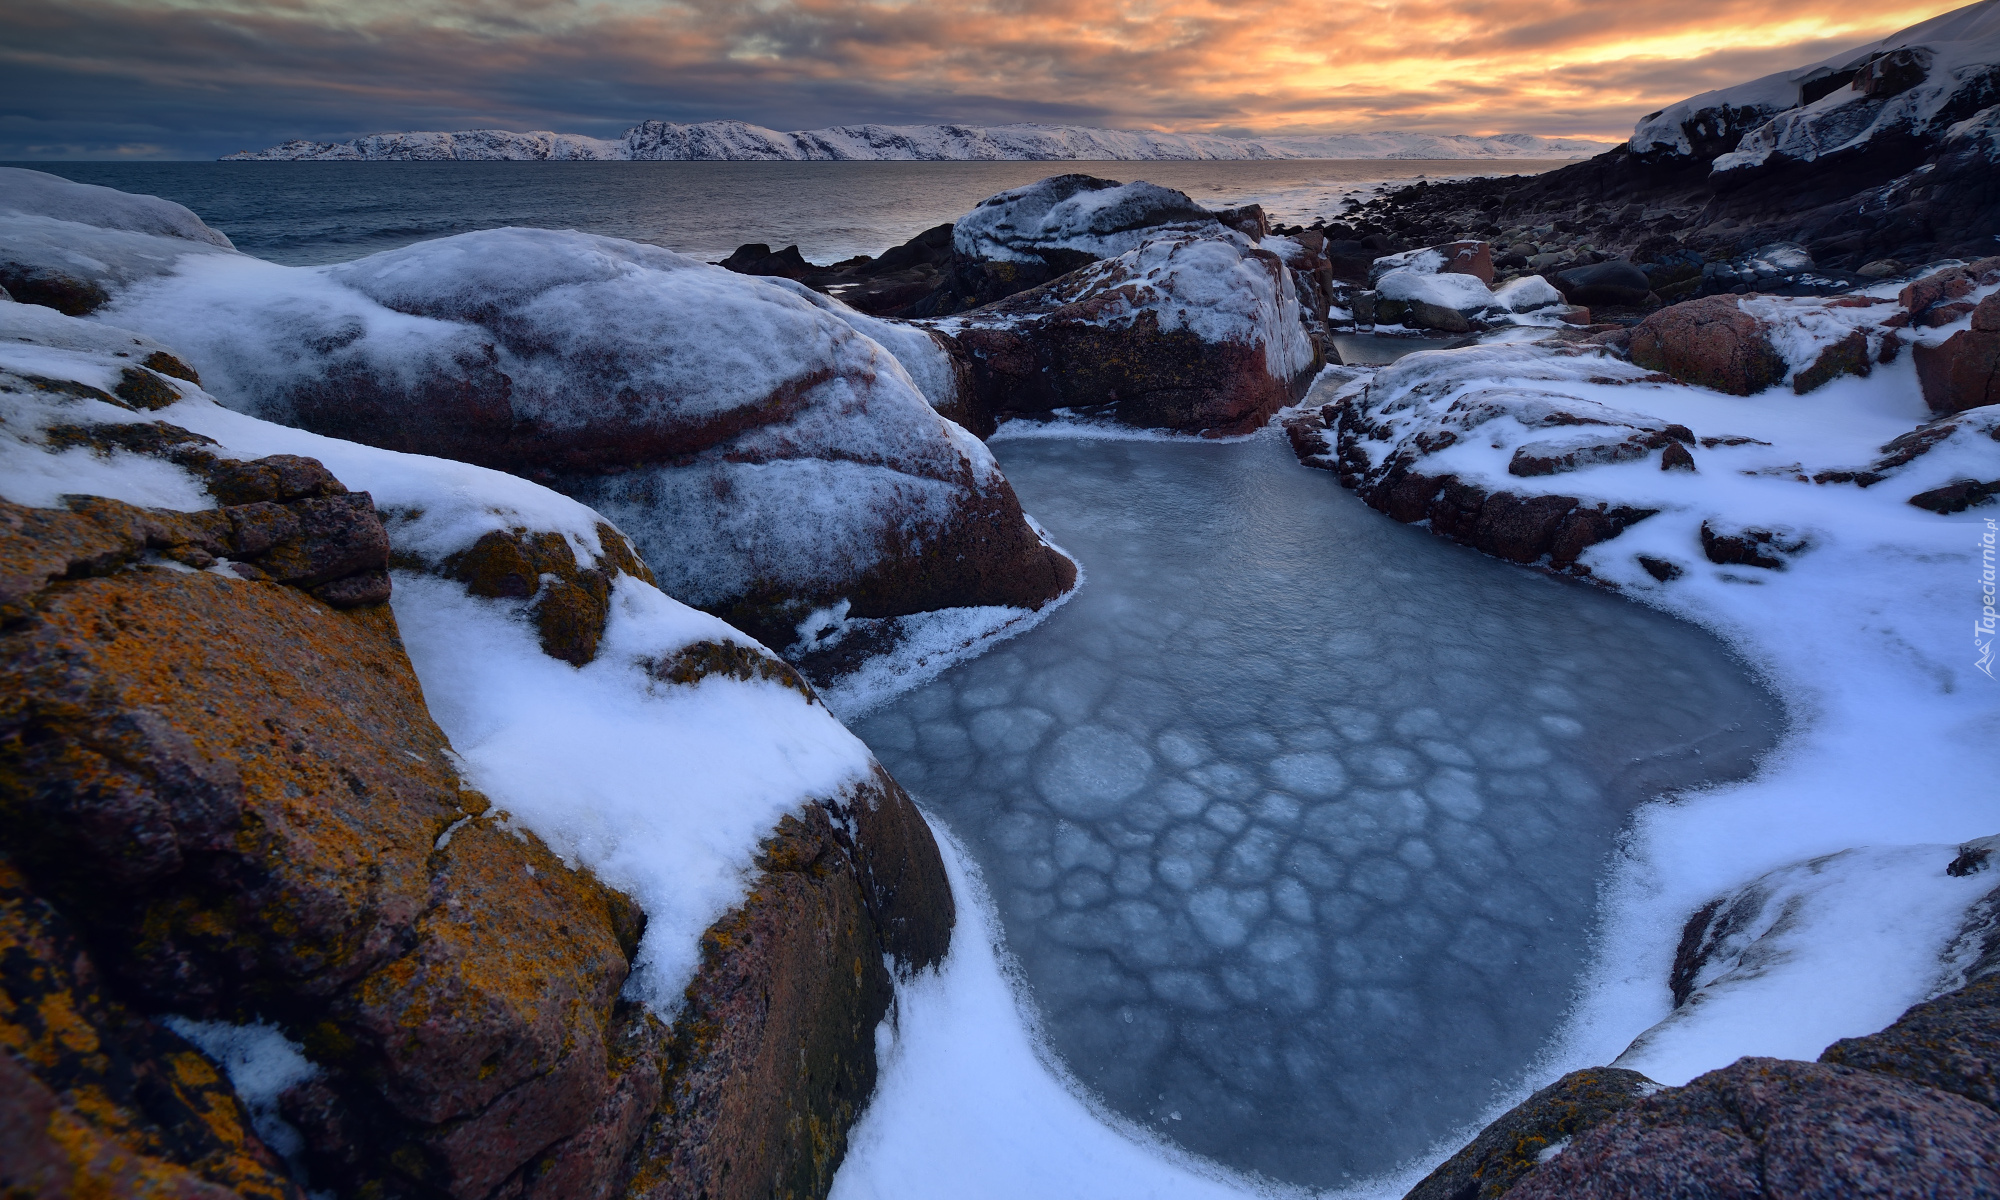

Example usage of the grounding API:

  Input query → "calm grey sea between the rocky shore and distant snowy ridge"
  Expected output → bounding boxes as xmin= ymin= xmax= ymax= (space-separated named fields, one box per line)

xmin=10 ymin=158 xmax=1564 ymax=264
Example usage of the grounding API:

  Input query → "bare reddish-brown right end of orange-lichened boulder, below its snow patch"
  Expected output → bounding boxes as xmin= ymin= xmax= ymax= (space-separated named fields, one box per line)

xmin=628 ymin=774 xmax=954 ymax=1200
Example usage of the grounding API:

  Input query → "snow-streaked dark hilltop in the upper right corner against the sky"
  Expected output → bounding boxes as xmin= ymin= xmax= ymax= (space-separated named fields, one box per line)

xmin=1628 ymin=0 xmax=2000 ymax=172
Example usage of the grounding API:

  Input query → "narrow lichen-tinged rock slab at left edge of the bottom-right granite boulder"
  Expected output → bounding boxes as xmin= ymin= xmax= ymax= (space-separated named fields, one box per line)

xmin=1404 ymin=1066 xmax=1658 ymax=1200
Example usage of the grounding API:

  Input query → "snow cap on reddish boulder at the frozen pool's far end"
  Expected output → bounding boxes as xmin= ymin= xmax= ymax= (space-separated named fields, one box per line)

xmin=928 ymin=228 xmax=1314 ymax=380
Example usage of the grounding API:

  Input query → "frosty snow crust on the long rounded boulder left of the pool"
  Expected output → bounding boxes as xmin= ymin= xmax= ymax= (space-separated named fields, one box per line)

xmin=90 ymin=228 xmax=1016 ymax=604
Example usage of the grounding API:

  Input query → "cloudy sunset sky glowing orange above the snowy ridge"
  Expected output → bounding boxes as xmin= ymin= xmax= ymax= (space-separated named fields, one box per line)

xmin=0 ymin=0 xmax=1956 ymax=160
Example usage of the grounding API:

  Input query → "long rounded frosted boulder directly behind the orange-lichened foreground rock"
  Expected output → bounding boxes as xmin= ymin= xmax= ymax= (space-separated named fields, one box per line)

xmin=0 ymin=170 xmax=1074 ymax=646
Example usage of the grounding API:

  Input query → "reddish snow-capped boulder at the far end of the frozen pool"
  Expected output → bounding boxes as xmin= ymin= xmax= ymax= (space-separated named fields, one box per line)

xmin=930 ymin=228 xmax=1318 ymax=434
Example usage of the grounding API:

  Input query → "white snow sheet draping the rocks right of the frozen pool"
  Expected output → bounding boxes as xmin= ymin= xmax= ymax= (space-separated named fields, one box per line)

xmin=1304 ymin=314 xmax=2000 ymax=1120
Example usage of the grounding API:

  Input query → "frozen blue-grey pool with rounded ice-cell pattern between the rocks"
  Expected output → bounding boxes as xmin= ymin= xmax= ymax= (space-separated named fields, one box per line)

xmin=852 ymin=436 xmax=1780 ymax=1184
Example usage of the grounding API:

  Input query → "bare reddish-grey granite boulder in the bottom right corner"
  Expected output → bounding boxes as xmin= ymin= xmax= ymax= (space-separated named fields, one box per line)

xmin=1508 ymin=1058 xmax=2000 ymax=1200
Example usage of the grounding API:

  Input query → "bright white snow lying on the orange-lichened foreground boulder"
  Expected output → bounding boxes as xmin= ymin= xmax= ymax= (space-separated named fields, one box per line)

xmin=0 ymin=304 xmax=880 ymax=1014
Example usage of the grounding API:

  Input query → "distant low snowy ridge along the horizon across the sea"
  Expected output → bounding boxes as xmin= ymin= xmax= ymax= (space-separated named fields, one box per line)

xmin=222 ymin=120 xmax=1612 ymax=162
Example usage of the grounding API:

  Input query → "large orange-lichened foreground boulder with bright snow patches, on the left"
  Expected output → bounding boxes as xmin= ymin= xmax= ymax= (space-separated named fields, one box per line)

xmin=0 ymin=300 xmax=954 ymax=1200
